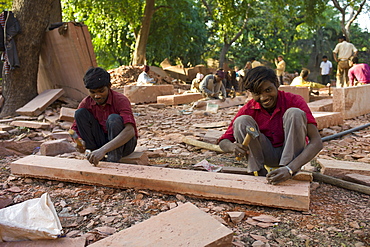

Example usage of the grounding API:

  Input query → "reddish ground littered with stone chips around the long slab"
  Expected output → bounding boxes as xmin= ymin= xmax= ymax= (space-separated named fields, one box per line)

xmin=0 ymin=89 xmax=370 ymax=247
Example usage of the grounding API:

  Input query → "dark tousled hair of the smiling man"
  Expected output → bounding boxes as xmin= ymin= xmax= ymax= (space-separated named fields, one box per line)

xmin=243 ymin=66 xmax=279 ymax=93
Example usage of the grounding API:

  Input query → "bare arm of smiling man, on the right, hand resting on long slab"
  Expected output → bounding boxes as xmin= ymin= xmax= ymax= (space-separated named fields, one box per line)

xmin=267 ymin=124 xmax=323 ymax=184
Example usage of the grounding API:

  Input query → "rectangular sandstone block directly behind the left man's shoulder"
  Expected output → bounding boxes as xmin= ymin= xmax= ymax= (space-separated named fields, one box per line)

xmin=124 ymin=85 xmax=174 ymax=104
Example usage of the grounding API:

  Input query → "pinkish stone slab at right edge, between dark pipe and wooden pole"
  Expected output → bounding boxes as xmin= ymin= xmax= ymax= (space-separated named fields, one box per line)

xmin=317 ymin=159 xmax=370 ymax=179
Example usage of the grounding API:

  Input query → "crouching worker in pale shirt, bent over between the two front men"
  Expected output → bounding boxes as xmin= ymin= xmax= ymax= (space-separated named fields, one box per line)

xmin=199 ymin=70 xmax=226 ymax=101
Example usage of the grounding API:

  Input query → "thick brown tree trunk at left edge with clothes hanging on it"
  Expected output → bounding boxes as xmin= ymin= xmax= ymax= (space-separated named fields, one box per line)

xmin=0 ymin=0 xmax=54 ymax=117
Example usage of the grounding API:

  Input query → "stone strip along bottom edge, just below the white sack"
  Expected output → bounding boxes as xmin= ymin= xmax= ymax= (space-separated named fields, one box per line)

xmin=0 ymin=237 xmax=86 ymax=247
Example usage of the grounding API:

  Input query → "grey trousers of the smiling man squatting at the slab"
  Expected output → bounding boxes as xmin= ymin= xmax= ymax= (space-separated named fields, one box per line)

xmin=233 ymin=108 xmax=307 ymax=172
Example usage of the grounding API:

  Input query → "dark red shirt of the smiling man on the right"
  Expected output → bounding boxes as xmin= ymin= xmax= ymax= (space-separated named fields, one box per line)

xmin=219 ymin=91 xmax=317 ymax=147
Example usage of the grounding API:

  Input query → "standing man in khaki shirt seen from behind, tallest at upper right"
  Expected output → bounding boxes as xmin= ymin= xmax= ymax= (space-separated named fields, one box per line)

xmin=333 ymin=36 xmax=357 ymax=88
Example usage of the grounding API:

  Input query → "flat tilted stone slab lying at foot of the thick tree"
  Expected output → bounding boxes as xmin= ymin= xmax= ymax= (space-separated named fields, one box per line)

xmin=15 ymin=88 xmax=64 ymax=116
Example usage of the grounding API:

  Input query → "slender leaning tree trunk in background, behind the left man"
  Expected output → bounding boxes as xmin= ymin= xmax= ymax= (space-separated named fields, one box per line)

xmin=132 ymin=0 xmax=155 ymax=65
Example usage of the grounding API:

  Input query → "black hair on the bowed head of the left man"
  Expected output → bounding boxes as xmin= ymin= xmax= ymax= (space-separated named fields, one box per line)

xmin=83 ymin=67 xmax=111 ymax=89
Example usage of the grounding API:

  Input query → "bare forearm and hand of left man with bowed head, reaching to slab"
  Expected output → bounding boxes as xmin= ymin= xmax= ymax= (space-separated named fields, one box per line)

xmin=87 ymin=123 xmax=135 ymax=165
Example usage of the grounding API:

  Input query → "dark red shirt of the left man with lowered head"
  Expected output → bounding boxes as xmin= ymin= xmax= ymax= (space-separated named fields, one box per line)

xmin=71 ymin=89 xmax=138 ymax=137
